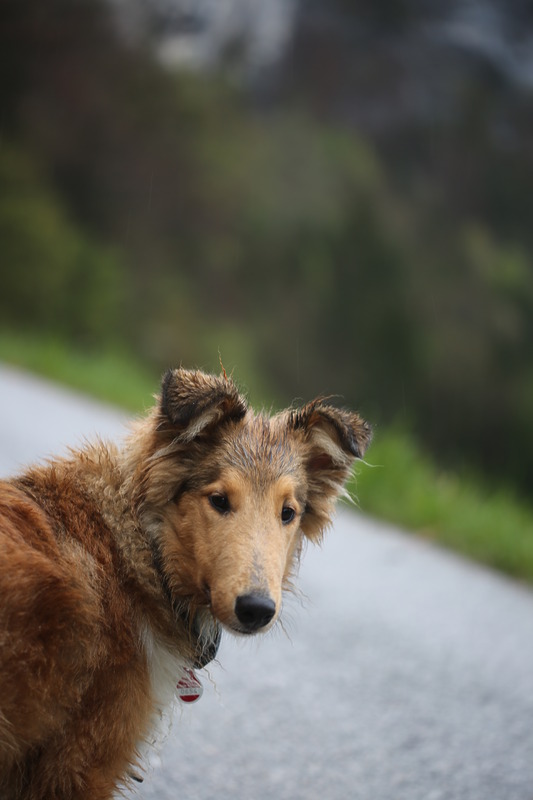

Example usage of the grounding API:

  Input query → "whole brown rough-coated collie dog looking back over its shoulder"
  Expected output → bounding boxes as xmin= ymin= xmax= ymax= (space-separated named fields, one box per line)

xmin=0 ymin=368 xmax=371 ymax=800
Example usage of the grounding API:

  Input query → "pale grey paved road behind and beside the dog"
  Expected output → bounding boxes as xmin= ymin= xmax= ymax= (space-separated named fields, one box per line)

xmin=0 ymin=368 xmax=533 ymax=800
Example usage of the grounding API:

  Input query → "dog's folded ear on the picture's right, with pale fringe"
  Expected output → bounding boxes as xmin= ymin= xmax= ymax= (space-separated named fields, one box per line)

xmin=288 ymin=399 xmax=372 ymax=539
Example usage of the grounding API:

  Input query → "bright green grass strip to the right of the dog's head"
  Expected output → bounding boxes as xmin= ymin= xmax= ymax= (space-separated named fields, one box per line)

xmin=351 ymin=431 xmax=533 ymax=583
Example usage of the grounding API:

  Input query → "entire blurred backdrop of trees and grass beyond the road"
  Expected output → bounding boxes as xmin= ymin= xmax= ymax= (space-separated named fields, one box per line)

xmin=0 ymin=0 xmax=533 ymax=581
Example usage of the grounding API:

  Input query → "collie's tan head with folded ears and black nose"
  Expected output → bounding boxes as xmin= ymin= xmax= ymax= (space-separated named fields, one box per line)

xmin=135 ymin=369 xmax=371 ymax=634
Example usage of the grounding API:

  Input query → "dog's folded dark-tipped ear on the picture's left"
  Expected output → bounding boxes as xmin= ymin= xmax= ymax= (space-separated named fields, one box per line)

xmin=160 ymin=369 xmax=247 ymax=443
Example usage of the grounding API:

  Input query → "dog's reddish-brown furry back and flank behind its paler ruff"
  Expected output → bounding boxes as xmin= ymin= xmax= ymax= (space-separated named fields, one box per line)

xmin=0 ymin=476 xmax=150 ymax=800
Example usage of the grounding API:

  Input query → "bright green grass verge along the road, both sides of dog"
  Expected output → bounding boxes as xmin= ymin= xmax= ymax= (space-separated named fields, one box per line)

xmin=0 ymin=331 xmax=533 ymax=584
